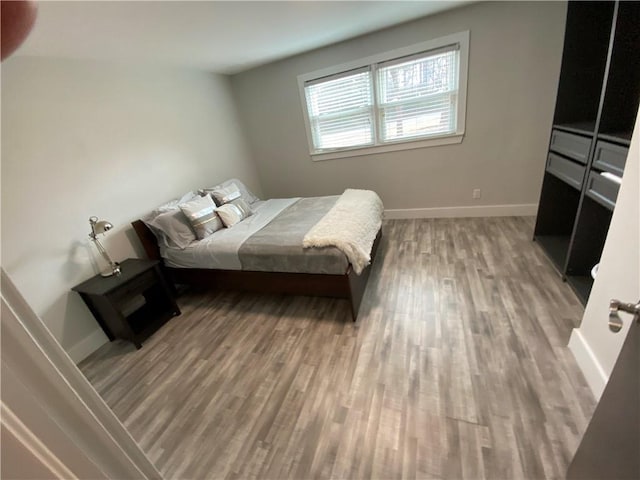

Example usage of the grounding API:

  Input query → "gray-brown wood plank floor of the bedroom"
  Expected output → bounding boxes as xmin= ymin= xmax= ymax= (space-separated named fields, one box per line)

xmin=80 ymin=218 xmax=595 ymax=479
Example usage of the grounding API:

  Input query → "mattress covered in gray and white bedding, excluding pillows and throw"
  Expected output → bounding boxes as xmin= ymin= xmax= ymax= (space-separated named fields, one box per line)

xmin=161 ymin=196 xmax=349 ymax=275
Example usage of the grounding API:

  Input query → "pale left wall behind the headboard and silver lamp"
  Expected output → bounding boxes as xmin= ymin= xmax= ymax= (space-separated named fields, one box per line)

xmin=2 ymin=57 xmax=261 ymax=361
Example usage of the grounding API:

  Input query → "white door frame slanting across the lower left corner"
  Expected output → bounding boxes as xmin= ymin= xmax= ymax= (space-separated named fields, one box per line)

xmin=0 ymin=269 xmax=162 ymax=479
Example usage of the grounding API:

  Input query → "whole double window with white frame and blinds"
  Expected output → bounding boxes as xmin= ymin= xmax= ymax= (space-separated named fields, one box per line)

xmin=298 ymin=32 xmax=469 ymax=160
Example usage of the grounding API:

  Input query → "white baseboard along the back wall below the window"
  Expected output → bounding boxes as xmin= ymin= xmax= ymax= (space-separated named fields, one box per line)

xmin=384 ymin=203 xmax=538 ymax=219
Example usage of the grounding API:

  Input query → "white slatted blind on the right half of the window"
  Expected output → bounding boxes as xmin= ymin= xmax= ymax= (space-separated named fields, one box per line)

xmin=377 ymin=45 xmax=458 ymax=142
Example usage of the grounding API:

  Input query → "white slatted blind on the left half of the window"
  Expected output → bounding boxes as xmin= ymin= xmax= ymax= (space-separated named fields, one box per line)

xmin=305 ymin=68 xmax=374 ymax=151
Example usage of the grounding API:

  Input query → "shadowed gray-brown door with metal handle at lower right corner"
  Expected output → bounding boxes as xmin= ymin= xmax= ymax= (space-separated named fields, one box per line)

xmin=567 ymin=308 xmax=640 ymax=480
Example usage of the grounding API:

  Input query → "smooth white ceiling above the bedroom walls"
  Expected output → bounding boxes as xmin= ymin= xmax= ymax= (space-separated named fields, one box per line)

xmin=16 ymin=1 xmax=468 ymax=74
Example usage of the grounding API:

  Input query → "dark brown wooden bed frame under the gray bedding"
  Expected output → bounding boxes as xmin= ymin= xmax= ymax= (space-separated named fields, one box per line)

xmin=131 ymin=220 xmax=382 ymax=322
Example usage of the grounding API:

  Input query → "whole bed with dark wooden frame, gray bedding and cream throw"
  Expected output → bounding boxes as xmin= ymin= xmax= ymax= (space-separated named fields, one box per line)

xmin=132 ymin=179 xmax=382 ymax=321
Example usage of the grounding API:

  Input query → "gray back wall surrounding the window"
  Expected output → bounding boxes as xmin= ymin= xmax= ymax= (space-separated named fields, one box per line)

xmin=232 ymin=2 xmax=566 ymax=214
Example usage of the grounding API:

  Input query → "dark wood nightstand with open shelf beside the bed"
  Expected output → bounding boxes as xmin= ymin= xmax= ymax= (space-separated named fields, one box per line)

xmin=72 ymin=258 xmax=180 ymax=348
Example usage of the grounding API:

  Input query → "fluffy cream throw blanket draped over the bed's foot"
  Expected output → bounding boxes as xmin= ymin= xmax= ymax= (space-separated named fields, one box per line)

xmin=302 ymin=189 xmax=384 ymax=275
